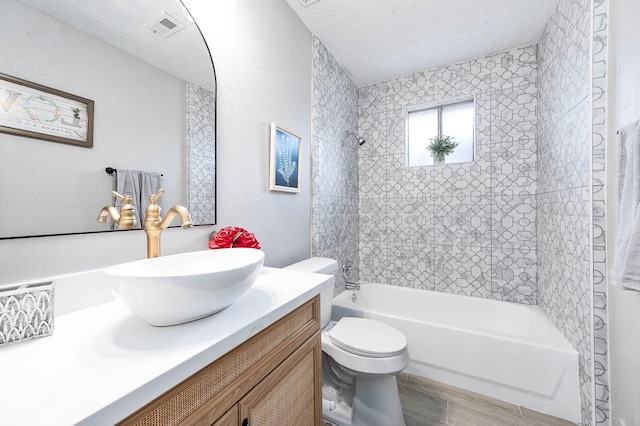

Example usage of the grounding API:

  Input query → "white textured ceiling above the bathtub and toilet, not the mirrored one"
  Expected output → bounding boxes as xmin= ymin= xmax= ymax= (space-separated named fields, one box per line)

xmin=286 ymin=0 xmax=558 ymax=87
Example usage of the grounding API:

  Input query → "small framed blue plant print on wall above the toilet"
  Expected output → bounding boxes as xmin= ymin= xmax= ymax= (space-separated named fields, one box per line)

xmin=269 ymin=123 xmax=302 ymax=192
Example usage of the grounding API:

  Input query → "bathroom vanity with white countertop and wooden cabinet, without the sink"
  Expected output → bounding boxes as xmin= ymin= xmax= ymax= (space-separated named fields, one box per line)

xmin=0 ymin=268 xmax=333 ymax=425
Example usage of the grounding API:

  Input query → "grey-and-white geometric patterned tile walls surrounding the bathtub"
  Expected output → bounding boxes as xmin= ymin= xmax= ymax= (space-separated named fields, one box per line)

xmin=313 ymin=0 xmax=610 ymax=425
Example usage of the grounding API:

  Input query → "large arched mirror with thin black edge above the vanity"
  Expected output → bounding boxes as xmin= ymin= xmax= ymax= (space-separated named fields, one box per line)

xmin=0 ymin=0 xmax=216 ymax=239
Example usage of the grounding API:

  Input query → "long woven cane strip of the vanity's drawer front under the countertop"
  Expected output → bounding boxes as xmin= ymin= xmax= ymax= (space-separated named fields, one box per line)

xmin=122 ymin=303 xmax=314 ymax=426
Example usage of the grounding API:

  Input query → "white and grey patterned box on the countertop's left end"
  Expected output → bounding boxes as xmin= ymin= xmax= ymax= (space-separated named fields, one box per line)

xmin=0 ymin=281 xmax=53 ymax=346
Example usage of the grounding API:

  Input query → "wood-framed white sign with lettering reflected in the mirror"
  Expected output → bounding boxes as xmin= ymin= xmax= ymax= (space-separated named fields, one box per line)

xmin=0 ymin=74 xmax=94 ymax=148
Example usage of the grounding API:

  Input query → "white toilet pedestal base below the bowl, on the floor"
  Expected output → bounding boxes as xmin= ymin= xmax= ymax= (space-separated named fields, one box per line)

xmin=322 ymin=373 xmax=405 ymax=426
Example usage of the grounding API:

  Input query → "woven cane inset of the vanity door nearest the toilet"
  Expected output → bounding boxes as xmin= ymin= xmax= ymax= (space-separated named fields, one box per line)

xmin=249 ymin=344 xmax=315 ymax=426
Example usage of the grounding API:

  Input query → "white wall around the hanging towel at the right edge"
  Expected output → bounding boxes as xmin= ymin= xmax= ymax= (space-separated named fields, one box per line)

xmin=607 ymin=0 xmax=640 ymax=426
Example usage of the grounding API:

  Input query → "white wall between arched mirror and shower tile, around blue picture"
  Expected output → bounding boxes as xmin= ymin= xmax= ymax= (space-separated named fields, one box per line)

xmin=184 ymin=0 xmax=312 ymax=266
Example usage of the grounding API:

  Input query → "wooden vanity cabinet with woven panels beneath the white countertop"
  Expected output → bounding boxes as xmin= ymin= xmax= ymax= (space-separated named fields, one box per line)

xmin=120 ymin=296 xmax=322 ymax=426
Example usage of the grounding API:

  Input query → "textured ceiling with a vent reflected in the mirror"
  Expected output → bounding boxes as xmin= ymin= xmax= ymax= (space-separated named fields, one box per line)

xmin=19 ymin=0 xmax=215 ymax=91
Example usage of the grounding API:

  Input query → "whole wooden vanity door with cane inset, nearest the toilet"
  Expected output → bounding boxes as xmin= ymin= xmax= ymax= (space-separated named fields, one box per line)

xmin=238 ymin=333 xmax=322 ymax=426
